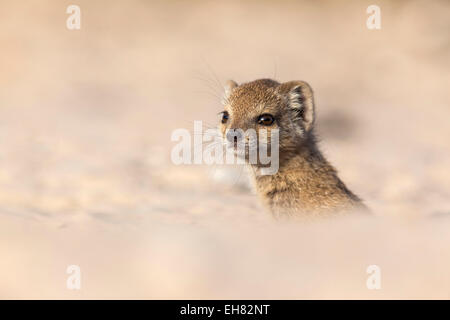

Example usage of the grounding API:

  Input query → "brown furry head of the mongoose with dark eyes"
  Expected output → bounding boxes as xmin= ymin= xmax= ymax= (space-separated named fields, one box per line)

xmin=219 ymin=79 xmax=315 ymax=162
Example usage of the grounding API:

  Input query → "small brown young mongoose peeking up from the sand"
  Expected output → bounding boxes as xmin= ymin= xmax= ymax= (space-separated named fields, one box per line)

xmin=220 ymin=79 xmax=365 ymax=217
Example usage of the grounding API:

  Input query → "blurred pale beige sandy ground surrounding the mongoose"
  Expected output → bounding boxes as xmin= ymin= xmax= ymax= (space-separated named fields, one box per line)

xmin=0 ymin=0 xmax=450 ymax=299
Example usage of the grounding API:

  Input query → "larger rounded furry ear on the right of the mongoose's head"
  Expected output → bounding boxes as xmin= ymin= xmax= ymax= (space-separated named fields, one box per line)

xmin=278 ymin=81 xmax=315 ymax=131
